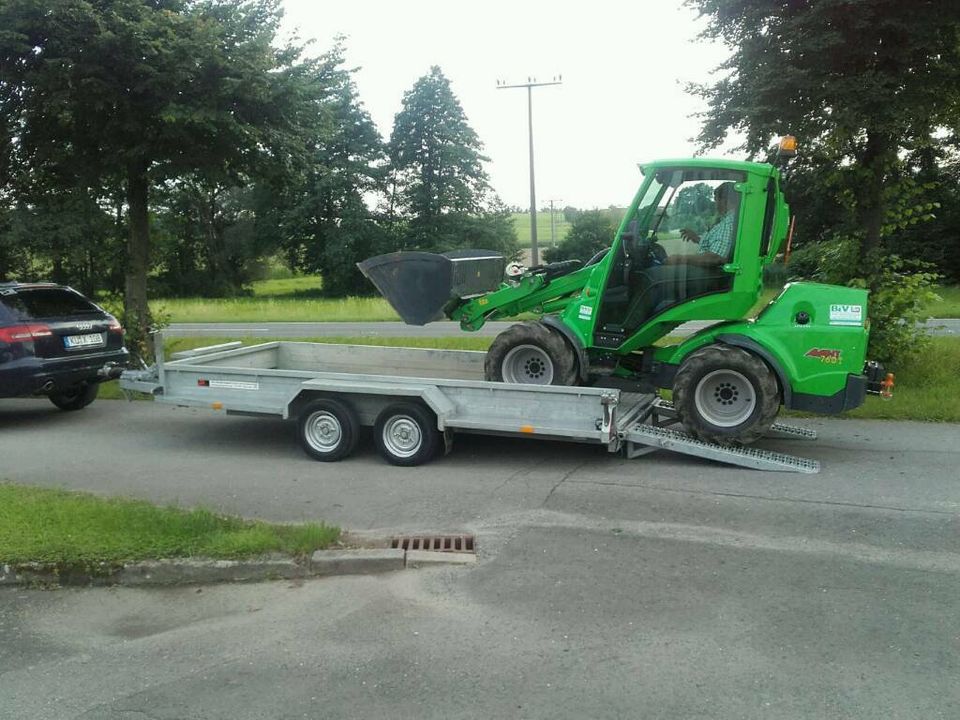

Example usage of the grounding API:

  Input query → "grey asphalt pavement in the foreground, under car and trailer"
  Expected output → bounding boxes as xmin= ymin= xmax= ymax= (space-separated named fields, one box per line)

xmin=0 ymin=400 xmax=960 ymax=720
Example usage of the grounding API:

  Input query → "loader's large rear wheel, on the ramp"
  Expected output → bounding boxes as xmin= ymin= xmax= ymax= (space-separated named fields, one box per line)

xmin=673 ymin=345 xmax=780 ymax=445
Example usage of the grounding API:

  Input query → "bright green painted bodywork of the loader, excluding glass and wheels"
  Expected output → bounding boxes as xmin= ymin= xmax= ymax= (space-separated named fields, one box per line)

xmin=447 ymin=158 xmax=868 ymax=410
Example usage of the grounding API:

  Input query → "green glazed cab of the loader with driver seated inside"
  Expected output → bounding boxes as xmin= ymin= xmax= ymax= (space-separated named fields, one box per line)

xmin=594 ymin=160 xmax=785 ymax=348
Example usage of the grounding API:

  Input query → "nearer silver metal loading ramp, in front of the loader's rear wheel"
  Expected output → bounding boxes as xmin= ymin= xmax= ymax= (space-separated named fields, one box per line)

xmin=624 ymin=425 xmax=820 ymax=475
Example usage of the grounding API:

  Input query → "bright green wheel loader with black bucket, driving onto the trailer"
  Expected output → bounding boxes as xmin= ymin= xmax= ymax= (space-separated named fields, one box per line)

xmin=359 ymin=145 xmax=893 ymax=445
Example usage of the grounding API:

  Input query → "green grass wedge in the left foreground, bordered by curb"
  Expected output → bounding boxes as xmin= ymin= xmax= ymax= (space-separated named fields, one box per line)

xmin=0 ymin=483 xmax=340 ymax=565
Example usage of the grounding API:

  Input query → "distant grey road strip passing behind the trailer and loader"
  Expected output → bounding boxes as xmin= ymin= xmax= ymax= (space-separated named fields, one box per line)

xmin=164 ymin=318 xmax=960 ymax=337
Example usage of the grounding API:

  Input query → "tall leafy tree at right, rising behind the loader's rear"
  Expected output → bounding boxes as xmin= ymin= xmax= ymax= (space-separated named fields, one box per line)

xmin=687 ymin=0 xmax=960 ymax=272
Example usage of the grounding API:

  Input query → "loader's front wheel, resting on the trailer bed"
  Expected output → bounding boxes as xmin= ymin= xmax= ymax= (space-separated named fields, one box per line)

xmin=483 ymin=322 xmax=578 ymax=385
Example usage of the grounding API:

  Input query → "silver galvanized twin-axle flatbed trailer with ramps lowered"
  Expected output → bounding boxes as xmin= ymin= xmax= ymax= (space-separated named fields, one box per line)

xmin=120 ymin=336 xmax=820 ymax=473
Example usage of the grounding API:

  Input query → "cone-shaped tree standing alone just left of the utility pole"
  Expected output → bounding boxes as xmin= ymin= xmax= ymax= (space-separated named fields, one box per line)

xmin=390 ymin=66 xmax=518 ymax=257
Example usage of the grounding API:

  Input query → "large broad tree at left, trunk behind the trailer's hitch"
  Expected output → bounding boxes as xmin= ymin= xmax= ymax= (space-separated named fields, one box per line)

xmin=0 ymin=0 xmax=311 ymax=348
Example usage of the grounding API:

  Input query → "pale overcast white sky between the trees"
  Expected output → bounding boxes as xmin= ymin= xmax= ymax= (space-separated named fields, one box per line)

xmin=284 ymin=0 xmax=726 ymax=207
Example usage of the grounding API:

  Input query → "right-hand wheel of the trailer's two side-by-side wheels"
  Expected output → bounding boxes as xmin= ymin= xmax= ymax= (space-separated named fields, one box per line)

xmin=373 ymin=403 xmax=443 ymax=467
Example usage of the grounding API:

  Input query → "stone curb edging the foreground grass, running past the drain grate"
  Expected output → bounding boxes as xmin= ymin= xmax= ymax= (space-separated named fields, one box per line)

xmin=0 ymin=548 xmax=477 ymax=588
